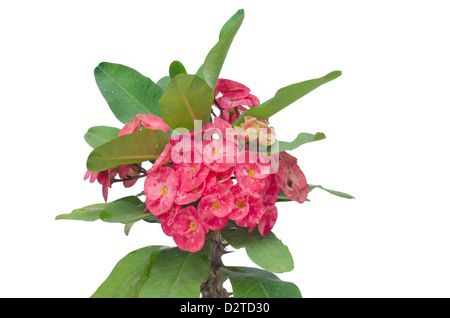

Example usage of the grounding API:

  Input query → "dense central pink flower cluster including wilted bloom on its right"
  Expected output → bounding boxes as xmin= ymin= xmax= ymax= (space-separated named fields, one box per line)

xmin=144 ymin=118 xmax=309 ymax=252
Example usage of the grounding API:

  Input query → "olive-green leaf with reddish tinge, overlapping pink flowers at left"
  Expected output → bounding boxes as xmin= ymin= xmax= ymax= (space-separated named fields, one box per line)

xmin=87 ymin=129 xmax=170 ymax=172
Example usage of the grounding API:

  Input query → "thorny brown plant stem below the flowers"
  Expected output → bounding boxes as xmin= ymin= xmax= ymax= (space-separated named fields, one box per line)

xmin=200 ymin=231 xmax=231 ymax=298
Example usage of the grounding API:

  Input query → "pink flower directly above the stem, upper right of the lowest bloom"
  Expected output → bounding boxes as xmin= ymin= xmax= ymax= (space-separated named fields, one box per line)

xmin=198 ymin=183 xmax=234 ymax=231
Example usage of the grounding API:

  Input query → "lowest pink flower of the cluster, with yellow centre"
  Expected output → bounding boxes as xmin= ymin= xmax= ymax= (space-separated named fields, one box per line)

xmin=172 ymin=205 xmax=208 ymax=253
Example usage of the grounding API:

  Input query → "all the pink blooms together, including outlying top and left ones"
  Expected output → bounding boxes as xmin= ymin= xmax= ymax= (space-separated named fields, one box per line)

xmin=85 ymin=79 xmax=310 ymax=252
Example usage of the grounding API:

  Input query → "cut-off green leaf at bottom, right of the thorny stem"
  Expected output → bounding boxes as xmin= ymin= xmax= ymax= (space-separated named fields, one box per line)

xmin=220 ymin=266 xmax=302 ymax=298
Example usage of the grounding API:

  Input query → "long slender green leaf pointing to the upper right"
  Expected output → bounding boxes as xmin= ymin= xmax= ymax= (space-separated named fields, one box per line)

xmin=233 ymin=71 xmax=342 ymax=126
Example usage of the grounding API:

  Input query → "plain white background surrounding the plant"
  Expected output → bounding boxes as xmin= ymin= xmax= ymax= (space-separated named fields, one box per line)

xmin=0 ymin=0 xmax=450 ymax=298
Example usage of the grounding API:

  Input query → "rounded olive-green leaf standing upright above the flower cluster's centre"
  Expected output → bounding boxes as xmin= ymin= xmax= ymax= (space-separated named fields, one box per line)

xmin=159 ymin=74 xmax=214 ymax=130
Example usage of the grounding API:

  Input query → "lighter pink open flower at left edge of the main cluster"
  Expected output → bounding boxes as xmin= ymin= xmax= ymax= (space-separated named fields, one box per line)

xmin=144 ymin=166 xmax=178 ymax=216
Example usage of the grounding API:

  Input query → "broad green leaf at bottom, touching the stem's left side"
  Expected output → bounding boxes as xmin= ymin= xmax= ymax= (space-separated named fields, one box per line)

xmin=139 ymin=247 xmax=210 ymax=298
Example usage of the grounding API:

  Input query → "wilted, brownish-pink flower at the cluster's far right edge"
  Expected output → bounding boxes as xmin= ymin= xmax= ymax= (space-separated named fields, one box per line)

xmin=275 ymin=154 xmax=309 ymax=203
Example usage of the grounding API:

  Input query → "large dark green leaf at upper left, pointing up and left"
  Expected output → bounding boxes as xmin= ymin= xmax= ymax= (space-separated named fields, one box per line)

xmin=94 ymin=62 xmax=163 ymax=124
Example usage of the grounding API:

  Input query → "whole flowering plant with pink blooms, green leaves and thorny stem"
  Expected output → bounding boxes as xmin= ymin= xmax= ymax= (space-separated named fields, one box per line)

xmin=56 ymin=10 xmax=352 ymax=297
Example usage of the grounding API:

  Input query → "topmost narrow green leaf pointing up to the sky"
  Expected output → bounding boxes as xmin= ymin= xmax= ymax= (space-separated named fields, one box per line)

xmin=200 ymin=9 xmax=245 ymax=90
